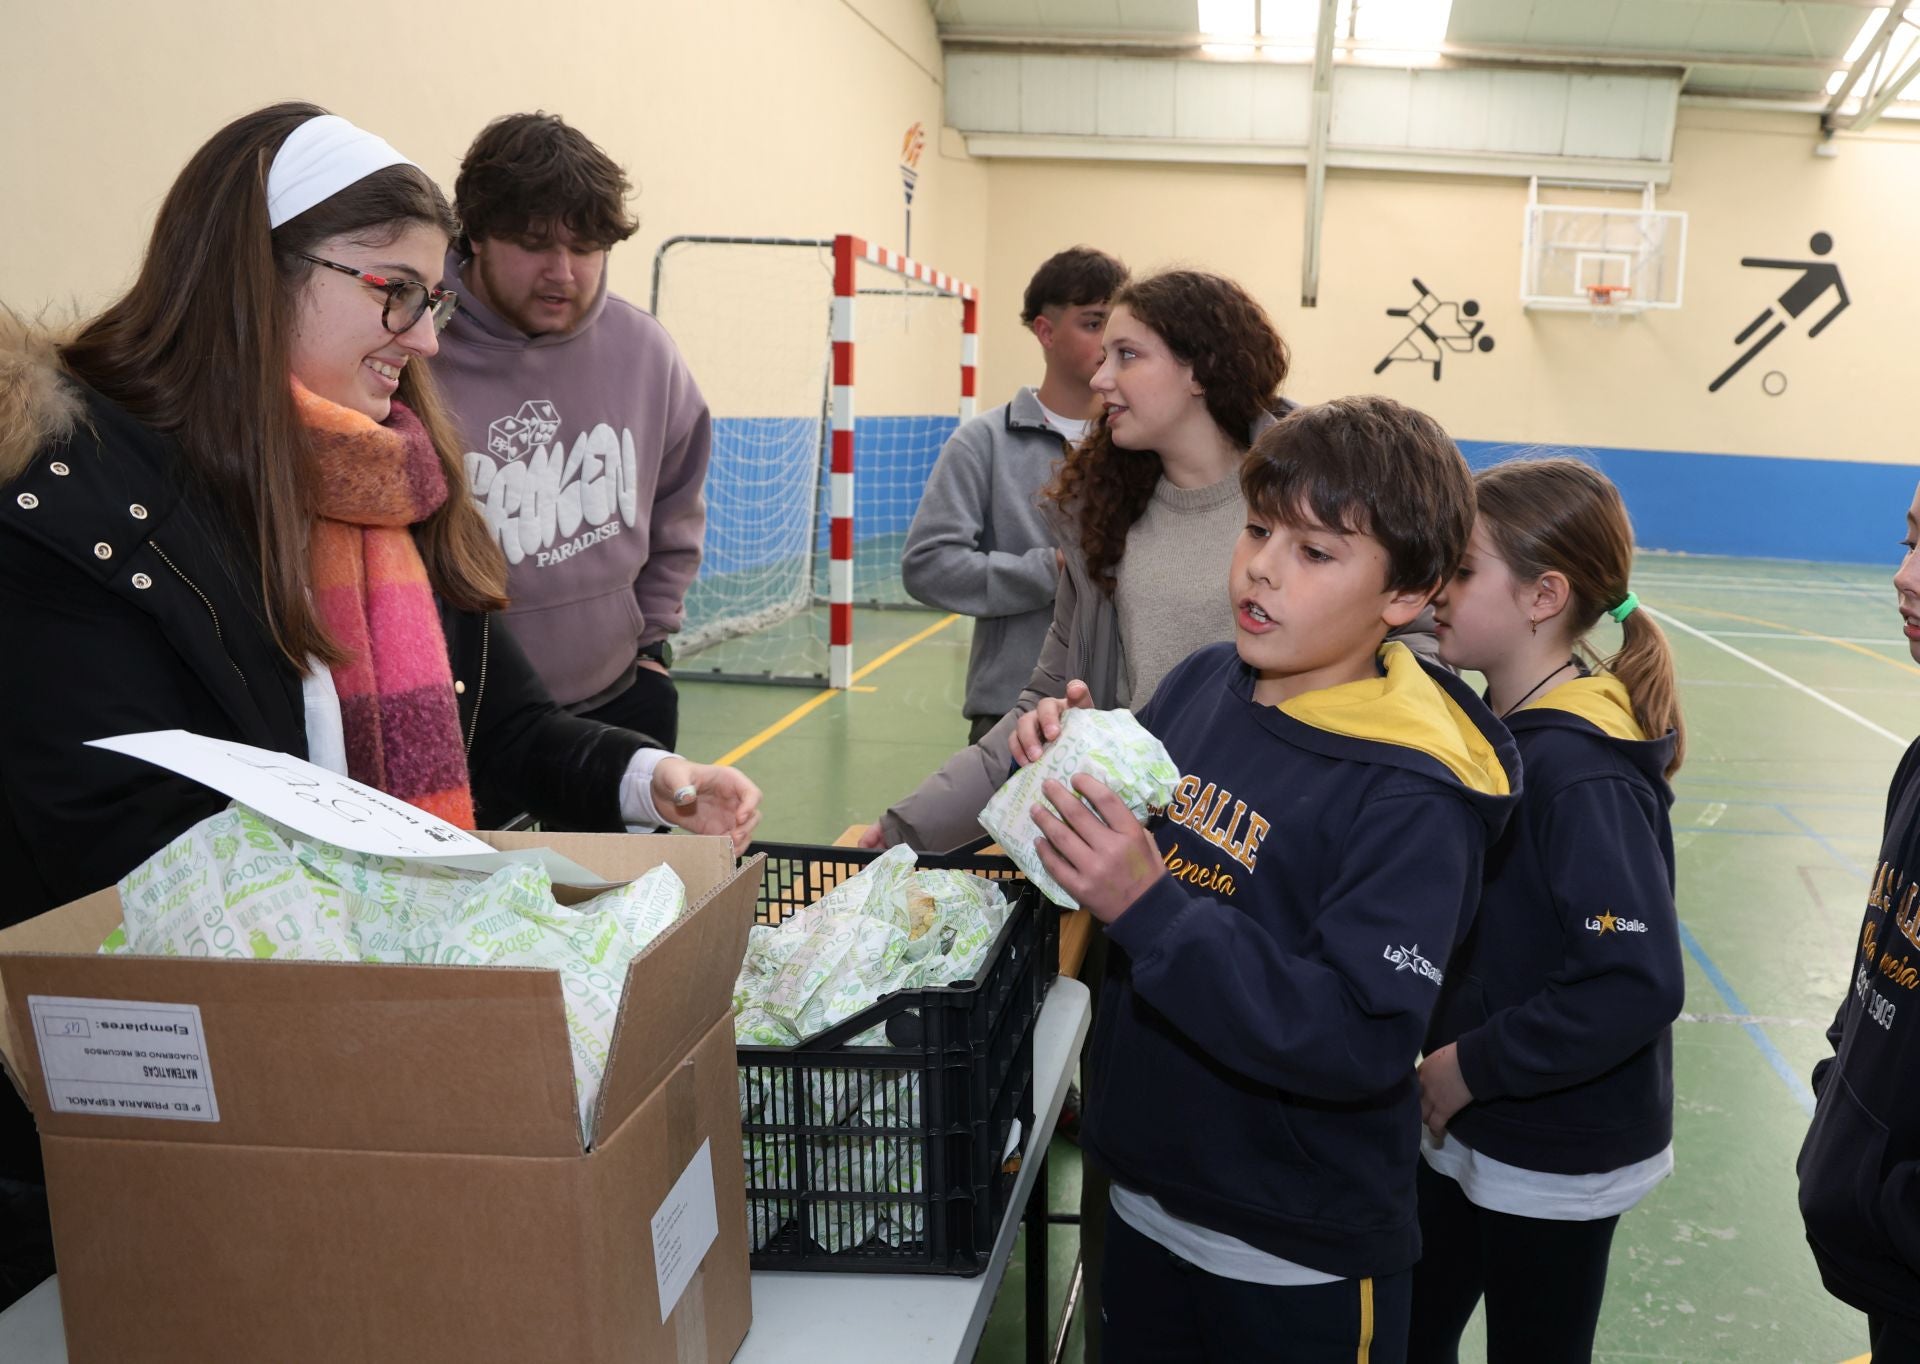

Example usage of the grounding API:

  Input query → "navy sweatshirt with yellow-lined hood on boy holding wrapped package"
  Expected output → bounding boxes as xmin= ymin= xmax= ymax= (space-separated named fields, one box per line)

xmin=1083 ymin=644 xmax=1521 ymax=1278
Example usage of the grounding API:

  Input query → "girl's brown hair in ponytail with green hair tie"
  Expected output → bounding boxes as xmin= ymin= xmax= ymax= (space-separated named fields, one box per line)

xmin=1473 ymin=457 xmax=1686 ymax=776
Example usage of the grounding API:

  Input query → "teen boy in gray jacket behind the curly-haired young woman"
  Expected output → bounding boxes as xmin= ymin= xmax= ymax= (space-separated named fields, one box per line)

xmin=900 ymin=246 xmax=1127 ymax=742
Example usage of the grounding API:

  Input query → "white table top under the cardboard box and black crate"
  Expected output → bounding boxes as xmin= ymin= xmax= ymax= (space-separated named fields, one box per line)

xmin=0 ymin=976 xmax=1092 ymax=1364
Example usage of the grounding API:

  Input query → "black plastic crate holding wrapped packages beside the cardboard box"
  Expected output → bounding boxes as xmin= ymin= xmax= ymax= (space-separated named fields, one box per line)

xmin=739 ymin=843 xmax=1060 ymax=1276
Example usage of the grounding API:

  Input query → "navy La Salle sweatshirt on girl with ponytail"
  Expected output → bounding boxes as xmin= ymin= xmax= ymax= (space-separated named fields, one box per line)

xmin=1427 ymin=674 xmax=1686 ymax=1174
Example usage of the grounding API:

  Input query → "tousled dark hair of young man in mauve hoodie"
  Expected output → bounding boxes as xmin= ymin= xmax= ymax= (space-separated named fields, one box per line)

xmin=453 ymin=111 xmax=639 ymax=256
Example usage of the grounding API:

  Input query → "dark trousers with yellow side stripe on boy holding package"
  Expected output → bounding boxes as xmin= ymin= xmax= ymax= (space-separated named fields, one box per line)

xmin=1100 ymin=1216 xmax=1413 ymax=1364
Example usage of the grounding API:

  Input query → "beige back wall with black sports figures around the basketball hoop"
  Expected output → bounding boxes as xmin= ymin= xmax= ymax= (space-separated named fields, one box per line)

xmin=981 ymin=108 xmax=1920 ymax=463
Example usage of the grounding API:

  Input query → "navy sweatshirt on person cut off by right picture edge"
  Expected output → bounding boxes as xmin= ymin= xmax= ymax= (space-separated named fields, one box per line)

xmin=1799 ymin=740 xmax=1920 ymax=1329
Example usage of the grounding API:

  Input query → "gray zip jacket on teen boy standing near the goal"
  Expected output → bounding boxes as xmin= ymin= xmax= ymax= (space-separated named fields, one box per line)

xmin=900 ymin=388 xmax=1066 ymax=719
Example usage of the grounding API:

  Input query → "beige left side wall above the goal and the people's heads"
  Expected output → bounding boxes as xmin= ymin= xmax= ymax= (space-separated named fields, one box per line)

xmin=0 ymin=0 xmax=987 ymax=395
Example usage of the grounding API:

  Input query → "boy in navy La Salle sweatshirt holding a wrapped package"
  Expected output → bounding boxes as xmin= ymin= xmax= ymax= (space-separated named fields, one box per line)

xmin=1035 ymin=398 xmax=1519 ymax=1364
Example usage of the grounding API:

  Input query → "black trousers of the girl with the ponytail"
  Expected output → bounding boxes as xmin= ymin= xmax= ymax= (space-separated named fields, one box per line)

xmin=1407 ymin=1160 xmax=1620 ymax=1364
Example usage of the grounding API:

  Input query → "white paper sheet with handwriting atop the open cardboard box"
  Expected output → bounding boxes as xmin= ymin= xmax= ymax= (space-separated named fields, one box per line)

xmin=90 ymin=730 xmax=493 ymax=859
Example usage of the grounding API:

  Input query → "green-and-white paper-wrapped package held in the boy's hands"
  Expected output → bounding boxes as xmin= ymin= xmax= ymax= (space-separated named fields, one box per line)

xmin=979 ymin=711 xmax=1181 ymax=909
